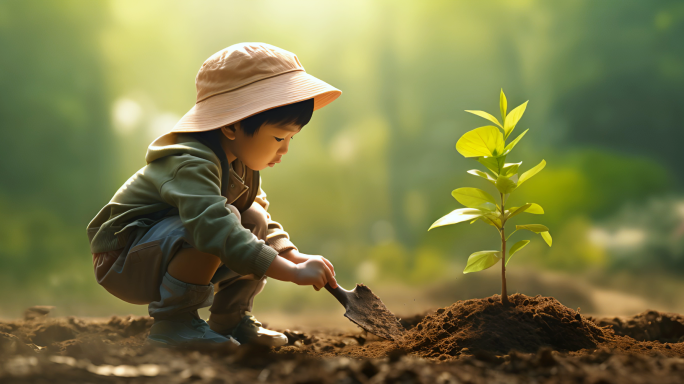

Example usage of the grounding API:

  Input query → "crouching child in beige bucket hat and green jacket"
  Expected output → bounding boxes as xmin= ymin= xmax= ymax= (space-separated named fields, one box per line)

xmin=87 ymin=43 xmax=341 ymax=346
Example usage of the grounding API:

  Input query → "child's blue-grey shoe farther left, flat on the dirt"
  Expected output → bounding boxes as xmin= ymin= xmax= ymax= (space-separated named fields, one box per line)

xmin=147 ymin=310 xmax=240 ymax=348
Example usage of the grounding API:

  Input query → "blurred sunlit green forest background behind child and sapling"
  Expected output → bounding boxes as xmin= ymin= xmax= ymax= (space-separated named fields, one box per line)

xmin=0 ymin=0 xmax=684 ymax=323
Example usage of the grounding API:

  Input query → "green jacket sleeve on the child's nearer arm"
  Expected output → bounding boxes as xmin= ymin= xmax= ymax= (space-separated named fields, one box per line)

xmin=159 ymin=160 xmax=278 ymax=278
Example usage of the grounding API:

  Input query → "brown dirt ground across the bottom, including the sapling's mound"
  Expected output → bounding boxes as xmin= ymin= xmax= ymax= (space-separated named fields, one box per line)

xmin=0 ymin=294 xmax=684 ymax=384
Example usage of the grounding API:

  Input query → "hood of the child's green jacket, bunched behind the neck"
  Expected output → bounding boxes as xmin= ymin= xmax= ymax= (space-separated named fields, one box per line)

xmin=145 ymin=132 xmax=220 ymax=164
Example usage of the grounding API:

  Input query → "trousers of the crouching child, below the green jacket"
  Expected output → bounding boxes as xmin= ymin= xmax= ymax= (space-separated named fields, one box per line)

xmin=95 ymin=204 xmax=267 ymax=328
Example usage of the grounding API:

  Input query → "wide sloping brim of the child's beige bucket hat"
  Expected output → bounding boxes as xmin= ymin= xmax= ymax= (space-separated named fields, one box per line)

xmin=167 ymin=71 xmax=342 ymax=134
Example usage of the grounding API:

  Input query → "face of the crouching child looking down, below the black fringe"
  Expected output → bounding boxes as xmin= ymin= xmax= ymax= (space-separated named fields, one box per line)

xmin=222 ymin=122 xmax=301 ymax=171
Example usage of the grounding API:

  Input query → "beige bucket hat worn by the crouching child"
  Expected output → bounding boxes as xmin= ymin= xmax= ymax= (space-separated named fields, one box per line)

xmin=169 ymin=43 xmax=342 ymax=133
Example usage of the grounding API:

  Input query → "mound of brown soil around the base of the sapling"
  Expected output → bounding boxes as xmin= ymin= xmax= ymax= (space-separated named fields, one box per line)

xmin=403 ymin=294 xmax=614 ymax=357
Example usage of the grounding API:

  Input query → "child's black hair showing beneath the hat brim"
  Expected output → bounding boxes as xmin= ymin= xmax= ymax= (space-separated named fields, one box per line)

xmin=240 ymin=99 xmax=314 ymax=136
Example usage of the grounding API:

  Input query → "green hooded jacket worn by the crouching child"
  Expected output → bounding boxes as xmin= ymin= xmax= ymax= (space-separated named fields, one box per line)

xmin=87 ymin=131 xmax=296 ymax=278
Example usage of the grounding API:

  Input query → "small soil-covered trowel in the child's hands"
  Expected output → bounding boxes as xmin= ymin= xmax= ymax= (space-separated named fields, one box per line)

xmin=325 ymin=284 xmax=404 ymax=341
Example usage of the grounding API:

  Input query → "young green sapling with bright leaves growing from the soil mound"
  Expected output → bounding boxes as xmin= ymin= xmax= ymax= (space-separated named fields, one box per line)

xmin=428 ymin=89 xmax=552 ymax=305
